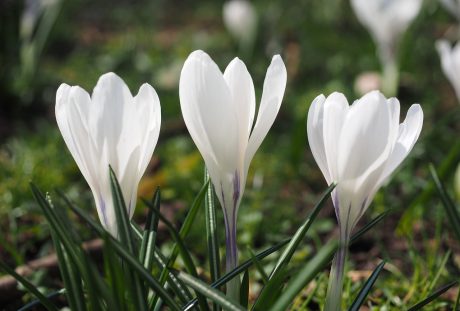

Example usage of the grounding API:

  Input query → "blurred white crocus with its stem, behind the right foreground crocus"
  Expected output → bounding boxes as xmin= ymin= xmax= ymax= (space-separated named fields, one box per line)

xmin=351 ymin=0 xmax=422 ymax=95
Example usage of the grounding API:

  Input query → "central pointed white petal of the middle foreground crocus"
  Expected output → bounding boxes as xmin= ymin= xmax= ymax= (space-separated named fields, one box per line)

xmin=224 ymin=57 xmax=256 ymax=146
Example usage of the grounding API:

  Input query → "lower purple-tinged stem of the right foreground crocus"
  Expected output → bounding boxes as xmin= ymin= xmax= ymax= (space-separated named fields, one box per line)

xmin=324 ymin=236 xmax=349 ymax=311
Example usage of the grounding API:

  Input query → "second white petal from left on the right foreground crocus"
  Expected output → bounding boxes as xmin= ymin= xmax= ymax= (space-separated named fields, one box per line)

xmin=323 ymin=93 xmax=349 ymax=182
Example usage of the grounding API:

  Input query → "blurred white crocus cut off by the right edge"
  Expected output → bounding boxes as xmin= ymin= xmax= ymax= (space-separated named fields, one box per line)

xmin=436 ymin=40 xmax=460 ymax=102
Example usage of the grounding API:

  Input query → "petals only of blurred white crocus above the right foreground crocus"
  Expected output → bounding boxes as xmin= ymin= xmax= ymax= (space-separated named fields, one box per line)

xmin=351 ymin=0 xmax=423 ymax=54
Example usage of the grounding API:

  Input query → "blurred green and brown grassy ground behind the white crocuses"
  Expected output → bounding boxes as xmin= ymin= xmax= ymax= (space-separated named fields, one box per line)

xmin=0 ymin=0 xmax=460 ymax=310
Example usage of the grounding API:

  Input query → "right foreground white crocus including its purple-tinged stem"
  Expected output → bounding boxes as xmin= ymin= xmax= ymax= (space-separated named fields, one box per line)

xmin=307 ymin=91 xmax=423 ymax=310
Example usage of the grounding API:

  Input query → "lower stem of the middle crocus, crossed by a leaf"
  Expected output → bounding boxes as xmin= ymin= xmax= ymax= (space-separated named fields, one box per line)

xmin=224 ymin=211 xmax=240 ymax=301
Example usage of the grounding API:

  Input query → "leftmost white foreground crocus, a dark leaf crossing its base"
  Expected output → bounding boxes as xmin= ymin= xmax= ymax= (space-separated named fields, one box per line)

xmin=56 ymin=73 xmax=161 ymax=237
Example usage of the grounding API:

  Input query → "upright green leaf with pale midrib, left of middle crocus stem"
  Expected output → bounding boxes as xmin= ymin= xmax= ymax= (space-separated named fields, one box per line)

xmin=204 ymin=169 xmax=220 ymax=290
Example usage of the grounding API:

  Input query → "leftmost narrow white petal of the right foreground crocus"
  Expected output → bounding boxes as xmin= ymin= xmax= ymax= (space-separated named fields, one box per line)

xmin=307 ymin=95 xmax=332 ymax=184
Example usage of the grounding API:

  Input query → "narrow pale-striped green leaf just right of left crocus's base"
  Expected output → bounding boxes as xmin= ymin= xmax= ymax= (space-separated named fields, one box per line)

xmin=139 ymin=188 xmax=161 ymax=271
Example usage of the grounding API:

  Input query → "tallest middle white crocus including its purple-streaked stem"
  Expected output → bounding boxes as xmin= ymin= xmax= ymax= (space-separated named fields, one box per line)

xmin=179 ymin=51 xmax=287 ymax=298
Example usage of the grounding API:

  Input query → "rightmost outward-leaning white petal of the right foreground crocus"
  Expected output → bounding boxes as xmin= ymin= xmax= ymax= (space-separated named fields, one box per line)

xmin=379 ymin=104 xmax=423 ymax=184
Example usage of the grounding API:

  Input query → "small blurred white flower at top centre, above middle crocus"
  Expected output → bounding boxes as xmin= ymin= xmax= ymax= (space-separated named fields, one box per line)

xmin=223 ymin=0 xmax=257 ymax=43
